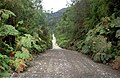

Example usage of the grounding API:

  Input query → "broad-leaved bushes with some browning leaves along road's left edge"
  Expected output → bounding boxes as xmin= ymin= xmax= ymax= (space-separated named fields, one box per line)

xmin=0 ymin=9 xmax=51 ymax=77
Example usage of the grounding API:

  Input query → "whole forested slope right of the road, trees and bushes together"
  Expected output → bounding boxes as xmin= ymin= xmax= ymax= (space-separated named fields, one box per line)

xmin=55 ymin=0 xmax=120 ymax=66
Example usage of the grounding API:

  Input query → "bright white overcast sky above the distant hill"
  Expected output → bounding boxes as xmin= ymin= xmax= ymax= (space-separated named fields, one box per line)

xmin=42 ymin=0 xmax=70 ymax=12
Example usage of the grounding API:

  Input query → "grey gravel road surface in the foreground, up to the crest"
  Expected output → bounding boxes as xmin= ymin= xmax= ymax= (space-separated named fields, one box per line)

xmin=13 ymin=49 xmax=120 ymax=78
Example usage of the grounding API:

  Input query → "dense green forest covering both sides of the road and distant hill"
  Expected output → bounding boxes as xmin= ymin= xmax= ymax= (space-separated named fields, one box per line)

xmin=0 ymin=0 xmax=120 ymax=77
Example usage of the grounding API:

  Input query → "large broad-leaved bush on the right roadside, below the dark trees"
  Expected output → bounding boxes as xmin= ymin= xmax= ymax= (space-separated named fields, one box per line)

xmin=78 ymin=17 xmax=120 ymax=63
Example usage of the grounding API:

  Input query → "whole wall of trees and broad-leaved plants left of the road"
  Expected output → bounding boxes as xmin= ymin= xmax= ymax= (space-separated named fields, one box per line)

xmin=0 ymin=0 xmax=51 ymax=77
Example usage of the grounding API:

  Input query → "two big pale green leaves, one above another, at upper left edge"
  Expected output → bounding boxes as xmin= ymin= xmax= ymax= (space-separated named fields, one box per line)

xmin=0 ymin=9 xmax=19 ymax=37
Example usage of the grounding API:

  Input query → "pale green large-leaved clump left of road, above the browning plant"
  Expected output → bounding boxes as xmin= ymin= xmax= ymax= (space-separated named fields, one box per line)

xmin=20 ymin=34 xmax=51 ymax=53
